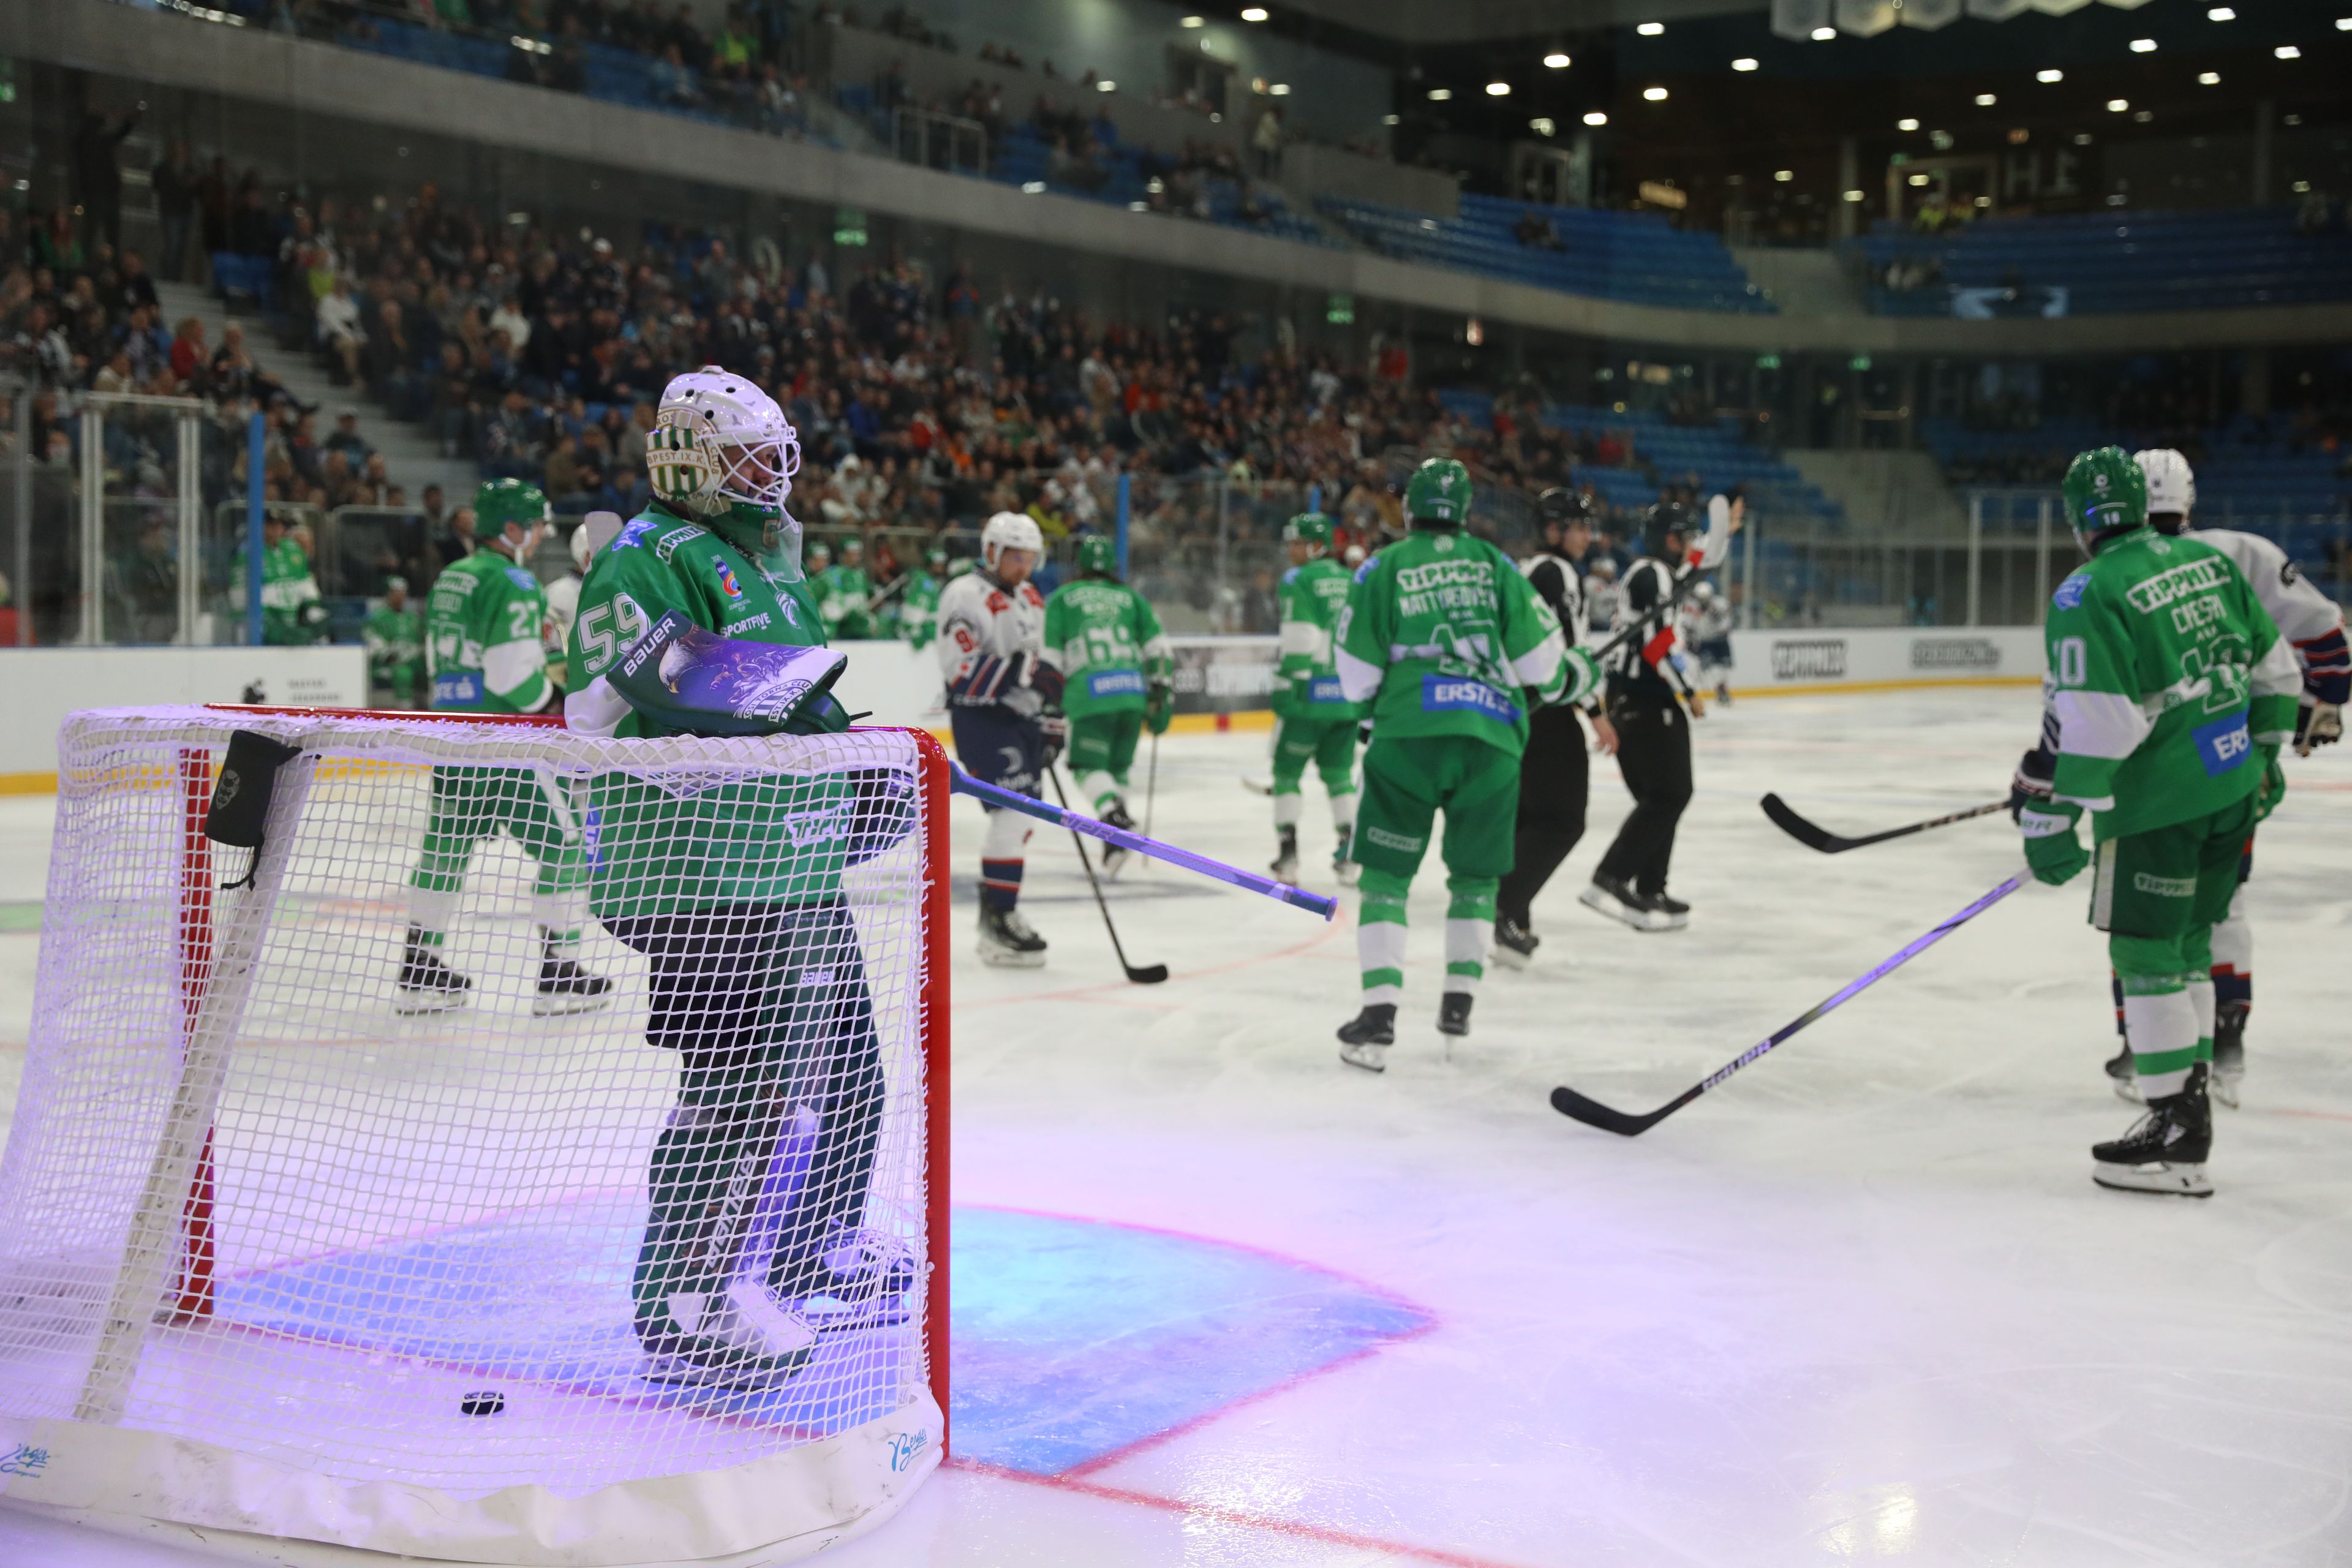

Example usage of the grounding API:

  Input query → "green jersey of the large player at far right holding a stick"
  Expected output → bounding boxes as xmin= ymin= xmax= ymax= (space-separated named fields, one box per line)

xmin=2046 ymin=529 xmax=2302 ymax=842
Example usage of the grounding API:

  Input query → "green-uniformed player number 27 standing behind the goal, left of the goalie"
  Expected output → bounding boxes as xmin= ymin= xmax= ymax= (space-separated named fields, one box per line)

xmin=393 ymin=480 xmax=611 ymax=1013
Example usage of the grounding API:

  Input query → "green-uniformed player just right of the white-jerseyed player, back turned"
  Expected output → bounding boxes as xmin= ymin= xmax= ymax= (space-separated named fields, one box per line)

xmin=1044 ymin=533 xmax=1176 ymax=870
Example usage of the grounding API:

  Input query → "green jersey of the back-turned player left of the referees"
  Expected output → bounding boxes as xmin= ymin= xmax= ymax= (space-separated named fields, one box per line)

xmin=1333 ymin=529 xmax=1593 ymax=757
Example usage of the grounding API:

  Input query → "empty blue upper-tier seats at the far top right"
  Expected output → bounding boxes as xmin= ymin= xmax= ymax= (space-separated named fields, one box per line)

xmin=1851 ymin=207 xmax=2352 ymax=315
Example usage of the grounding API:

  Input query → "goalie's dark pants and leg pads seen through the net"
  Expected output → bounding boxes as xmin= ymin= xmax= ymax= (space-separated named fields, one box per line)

xmin=607 ymin=898 xmax=882 ymax=1344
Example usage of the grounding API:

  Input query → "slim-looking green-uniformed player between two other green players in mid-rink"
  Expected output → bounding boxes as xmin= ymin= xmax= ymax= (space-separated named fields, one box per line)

xmin=1272 ymin=513 xmax=1357 ymax=884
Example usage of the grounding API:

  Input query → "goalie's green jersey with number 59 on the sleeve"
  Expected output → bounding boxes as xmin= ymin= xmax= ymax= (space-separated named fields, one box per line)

xmin=565 ymin=503 xmax=854 ymax=919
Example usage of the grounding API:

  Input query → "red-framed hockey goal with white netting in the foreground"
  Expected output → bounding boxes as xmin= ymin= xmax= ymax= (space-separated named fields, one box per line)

xmin=0 ymin=707 xmax=948 ymax=1563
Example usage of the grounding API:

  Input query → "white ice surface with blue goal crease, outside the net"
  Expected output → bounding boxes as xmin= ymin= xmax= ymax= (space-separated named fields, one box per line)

xmin=0 ymin=687 xmax=2352 ymax=1568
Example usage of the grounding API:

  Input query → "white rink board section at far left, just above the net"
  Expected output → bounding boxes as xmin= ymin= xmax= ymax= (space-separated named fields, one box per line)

xmin=0 ymin=644 xmax=367 ymax=776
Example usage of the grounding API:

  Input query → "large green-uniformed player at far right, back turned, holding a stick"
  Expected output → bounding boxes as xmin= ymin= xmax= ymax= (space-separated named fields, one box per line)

xmin=2018 ymin=447 xmax=2302 ymax=1197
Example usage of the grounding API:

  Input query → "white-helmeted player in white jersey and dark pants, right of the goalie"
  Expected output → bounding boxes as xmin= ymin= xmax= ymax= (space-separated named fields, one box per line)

xmin=938 ymin=513 xmax=1068 ymax=968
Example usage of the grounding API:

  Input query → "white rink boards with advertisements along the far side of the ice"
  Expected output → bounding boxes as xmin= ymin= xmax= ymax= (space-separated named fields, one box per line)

xmin=0 ymin=625 xmax=2041 ymax=794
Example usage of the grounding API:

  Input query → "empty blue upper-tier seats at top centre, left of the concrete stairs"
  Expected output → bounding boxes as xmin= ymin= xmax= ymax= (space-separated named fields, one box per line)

xmin=1317 ymin=195 xmax=1773 ymax=312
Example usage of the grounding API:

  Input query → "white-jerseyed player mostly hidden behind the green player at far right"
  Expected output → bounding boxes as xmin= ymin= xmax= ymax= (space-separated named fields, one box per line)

xmin=2011 ymin=447 xmax=2352 ymax=1110
